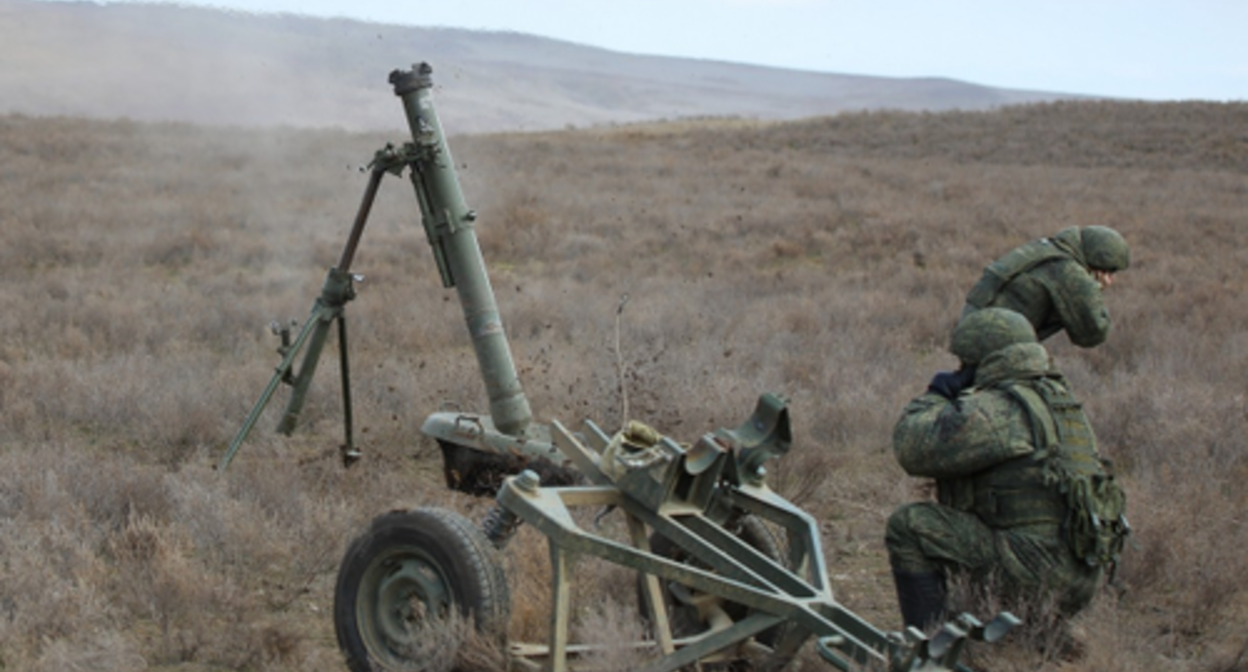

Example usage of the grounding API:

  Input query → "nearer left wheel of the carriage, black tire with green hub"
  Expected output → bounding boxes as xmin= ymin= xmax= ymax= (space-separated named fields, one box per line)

xmin=333 ymin=508 xmax=510 ymax=672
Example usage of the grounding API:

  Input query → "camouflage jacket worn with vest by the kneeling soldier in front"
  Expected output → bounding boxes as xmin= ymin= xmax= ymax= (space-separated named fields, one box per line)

xmin=892 ymin=343 xmax=1131 ymax=568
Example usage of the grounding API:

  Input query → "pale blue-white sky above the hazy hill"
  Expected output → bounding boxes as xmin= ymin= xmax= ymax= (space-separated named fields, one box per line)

xmin=73 ymin=0 xmax=1248 ymax=100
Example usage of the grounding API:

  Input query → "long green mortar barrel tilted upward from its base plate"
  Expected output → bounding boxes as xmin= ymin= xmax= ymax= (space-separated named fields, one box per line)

xmin=389 ymin=64 xmax=533 ymax=436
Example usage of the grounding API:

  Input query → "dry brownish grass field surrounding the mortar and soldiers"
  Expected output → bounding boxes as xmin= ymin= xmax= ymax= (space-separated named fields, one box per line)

xmin=0 ymin=102 xmax=1248 ymax=672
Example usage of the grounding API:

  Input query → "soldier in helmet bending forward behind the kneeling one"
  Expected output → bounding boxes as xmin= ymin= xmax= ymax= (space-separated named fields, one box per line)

xmin=962 ymin=226 xmax=1131 ymax=347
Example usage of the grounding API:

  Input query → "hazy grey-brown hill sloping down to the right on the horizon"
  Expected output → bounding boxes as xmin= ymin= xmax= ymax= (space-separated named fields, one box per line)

xmin=0 ymin=0 xmax=1076 ymax=132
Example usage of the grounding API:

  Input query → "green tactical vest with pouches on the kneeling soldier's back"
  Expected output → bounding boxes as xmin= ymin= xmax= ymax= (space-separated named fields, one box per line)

xmin=942 ymin=376 xmax=1131 ymax=571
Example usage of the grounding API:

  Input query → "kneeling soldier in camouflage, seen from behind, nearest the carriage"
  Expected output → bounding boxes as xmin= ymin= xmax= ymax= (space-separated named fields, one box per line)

xmin=885 ymin=309 xmax=1128 ymax=628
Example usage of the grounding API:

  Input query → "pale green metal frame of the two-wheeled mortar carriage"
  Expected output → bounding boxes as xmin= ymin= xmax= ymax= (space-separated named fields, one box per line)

xmin=498 ymin=407 xmax=1017 ymax=672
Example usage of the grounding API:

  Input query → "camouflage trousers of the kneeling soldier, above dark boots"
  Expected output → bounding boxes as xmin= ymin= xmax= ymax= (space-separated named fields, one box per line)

xmin=885 ymin=502 xmax=1101 ymax=613
